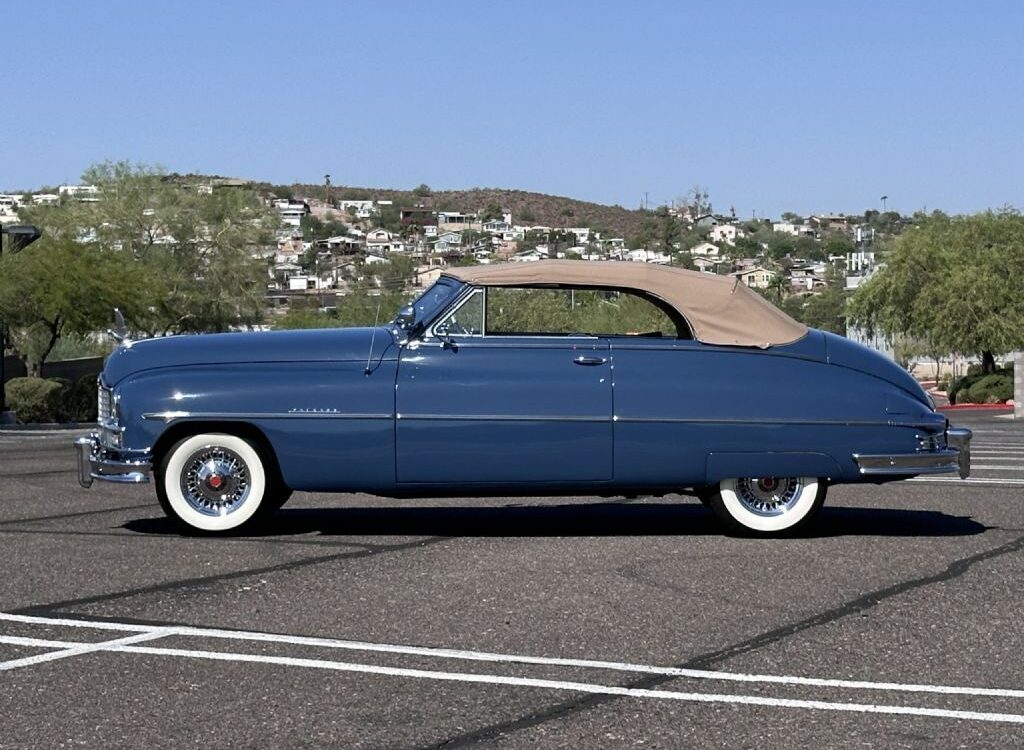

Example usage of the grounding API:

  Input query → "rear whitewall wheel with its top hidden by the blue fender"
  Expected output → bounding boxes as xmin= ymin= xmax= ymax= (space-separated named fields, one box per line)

xmin=708 ymin=476 xmax=828 ymax=536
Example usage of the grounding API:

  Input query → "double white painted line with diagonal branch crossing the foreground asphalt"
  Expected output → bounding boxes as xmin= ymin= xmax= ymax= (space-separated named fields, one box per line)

xmin=0 ymin=613 xmax=1024 ymax=723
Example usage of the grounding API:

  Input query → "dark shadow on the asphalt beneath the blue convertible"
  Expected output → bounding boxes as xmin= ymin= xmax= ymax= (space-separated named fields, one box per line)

xmin=124 ymin=502 xmax=987 ymax=538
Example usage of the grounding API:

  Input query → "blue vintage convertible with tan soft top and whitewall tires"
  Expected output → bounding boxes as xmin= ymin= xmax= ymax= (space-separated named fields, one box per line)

xmin=76 ymin=261 xmax=971 ymax=535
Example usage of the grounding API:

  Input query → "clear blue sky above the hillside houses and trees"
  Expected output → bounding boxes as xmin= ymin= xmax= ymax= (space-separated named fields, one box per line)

xmin=8 ymin=0 xmax=1024 ymax=216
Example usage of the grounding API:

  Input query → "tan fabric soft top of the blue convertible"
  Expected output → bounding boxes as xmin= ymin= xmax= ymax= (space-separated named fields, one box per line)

xmin=444 ymin=260 xmax=807 ymax=348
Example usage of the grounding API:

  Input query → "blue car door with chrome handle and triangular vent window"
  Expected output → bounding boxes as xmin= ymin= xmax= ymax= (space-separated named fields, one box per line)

xmin=395 ymin=290 xmax=612 ymax=486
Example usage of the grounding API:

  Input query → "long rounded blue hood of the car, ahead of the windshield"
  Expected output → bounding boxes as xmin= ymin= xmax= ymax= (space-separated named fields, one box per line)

xmin=102 ymin=327 xmax=397 ymax=385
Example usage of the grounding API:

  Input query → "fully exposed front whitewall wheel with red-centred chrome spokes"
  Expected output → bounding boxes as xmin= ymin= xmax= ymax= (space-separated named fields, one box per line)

xmin=156 ymin=432 xmax=271 ymax=533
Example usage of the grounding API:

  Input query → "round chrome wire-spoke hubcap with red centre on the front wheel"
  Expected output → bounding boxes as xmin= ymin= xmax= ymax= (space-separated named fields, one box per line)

xmin=181 ymin=446 xmax=250 ymax=515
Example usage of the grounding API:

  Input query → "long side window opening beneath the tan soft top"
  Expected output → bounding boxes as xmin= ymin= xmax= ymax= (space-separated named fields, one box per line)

xmin=486 ymin=287 xmax=688 ymax=338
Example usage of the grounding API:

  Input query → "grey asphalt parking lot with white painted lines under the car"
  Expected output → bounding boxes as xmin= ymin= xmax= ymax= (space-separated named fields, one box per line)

xmin=0 ymin=413 xmax=1024 ymax=749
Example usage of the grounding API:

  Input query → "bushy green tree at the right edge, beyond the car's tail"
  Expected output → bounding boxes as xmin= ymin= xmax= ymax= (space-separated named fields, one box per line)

xmin=850 ymin=209 xmax=1024 ymax=373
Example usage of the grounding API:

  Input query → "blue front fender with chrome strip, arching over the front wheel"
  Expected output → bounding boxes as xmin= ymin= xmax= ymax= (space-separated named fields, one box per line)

xmin=115 ymin=361 xmax=396 ymax=490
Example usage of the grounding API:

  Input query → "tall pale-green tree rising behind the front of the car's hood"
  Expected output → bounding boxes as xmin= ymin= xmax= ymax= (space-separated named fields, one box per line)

xmin=17 ymin=162 xmax=280 ymax=346
